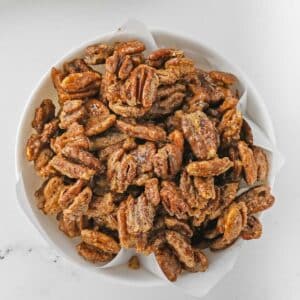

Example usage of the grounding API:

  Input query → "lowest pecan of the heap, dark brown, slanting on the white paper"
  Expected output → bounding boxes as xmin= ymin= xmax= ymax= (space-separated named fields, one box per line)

xmin=154 ymin=247 xmax=182 ymax=281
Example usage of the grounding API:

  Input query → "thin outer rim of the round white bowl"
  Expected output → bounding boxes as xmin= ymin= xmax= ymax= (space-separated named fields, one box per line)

xmin=14 ymin=27 xmax=276 ymax=287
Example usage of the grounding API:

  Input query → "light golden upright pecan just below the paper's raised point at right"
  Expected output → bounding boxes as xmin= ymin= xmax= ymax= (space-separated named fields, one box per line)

xmin=218 ymin=108 xmax=243 ymax=146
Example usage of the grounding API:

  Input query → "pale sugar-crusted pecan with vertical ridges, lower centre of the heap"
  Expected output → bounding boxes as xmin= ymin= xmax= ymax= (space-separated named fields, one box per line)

xmin=126 ymin=194 xmax=155 ymax=234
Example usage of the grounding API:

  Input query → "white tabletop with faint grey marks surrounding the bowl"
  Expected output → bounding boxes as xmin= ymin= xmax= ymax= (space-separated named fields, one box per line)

xmin=0 ymin=0 xmax=300 ymax=300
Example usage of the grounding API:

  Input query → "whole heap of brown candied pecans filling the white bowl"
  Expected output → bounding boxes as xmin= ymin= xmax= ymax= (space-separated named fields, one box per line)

xmin=26 ymin=40 xmax=274 ymax=281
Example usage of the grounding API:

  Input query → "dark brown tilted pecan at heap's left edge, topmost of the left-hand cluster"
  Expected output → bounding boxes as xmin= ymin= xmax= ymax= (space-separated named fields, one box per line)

xmin=31 ymin=99 xmax=55 ymax=133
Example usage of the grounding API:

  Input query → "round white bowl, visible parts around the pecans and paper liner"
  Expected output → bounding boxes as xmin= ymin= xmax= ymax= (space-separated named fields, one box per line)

xmin=15 ymin=30 xmax=275 ymax=288
